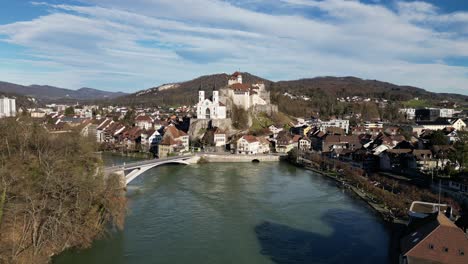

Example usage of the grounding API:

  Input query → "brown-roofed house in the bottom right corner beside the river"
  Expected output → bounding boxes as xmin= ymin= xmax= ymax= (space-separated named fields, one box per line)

xmin=400 ymin=213 xmax=468 ymax=264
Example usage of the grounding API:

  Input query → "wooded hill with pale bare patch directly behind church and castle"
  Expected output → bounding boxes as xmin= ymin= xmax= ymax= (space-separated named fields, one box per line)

xmin=110 ymin=73 xmax=271 ymax=106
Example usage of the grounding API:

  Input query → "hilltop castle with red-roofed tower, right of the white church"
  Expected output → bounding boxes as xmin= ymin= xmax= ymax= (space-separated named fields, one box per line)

xmin=223 ymin=72 xmax=270 ymax=110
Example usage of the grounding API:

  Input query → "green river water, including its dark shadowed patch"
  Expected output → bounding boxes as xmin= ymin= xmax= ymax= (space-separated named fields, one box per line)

xmin=54 ymin=157 xmax=389 ymax=264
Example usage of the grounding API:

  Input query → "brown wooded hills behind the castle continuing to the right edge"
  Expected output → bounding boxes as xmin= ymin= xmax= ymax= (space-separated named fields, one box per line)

xmin=112 ymin=73 xmax=468 ymax=106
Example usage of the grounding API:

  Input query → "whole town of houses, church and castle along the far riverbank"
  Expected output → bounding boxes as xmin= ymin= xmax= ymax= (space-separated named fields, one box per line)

xmin=0 ymin=72 xmax=468 ymax=263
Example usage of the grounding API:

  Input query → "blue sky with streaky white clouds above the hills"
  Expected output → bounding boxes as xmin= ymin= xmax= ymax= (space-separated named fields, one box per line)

xmin=0 ymin=0 xmax=468 ymax=94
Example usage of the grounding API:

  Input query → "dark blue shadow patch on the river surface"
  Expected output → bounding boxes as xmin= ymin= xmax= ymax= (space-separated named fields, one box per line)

xmin=255 ymin=210 xmax=388 ymax=264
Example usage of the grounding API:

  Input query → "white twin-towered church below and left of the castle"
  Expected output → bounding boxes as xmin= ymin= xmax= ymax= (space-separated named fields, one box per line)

xmin=197 ymin=90 xmax=226 ymax=119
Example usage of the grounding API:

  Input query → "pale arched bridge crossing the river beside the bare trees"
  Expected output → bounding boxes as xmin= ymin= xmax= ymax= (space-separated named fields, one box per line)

xmin=104 ymin=155 xmax=194 ymax=184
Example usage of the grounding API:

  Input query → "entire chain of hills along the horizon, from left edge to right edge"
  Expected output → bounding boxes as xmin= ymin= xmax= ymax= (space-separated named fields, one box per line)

xmin=0 ymin=73 xmax=468 ymax=108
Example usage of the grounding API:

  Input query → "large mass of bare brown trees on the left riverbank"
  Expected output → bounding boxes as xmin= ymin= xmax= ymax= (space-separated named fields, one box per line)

xmin=0 ymin=119 xmax=125 ymax=263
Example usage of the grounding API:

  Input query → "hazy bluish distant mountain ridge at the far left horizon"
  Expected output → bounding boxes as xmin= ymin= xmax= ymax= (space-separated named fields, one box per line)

xmin=0 ymin=82 xmax=126 ymax=102
